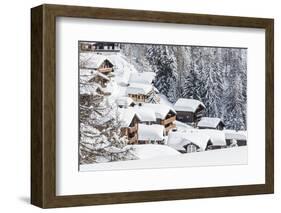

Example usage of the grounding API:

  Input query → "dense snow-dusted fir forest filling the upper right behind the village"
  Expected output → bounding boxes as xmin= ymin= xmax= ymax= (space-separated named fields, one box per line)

xmin=122 ymin=44 xmax=247 ymax=130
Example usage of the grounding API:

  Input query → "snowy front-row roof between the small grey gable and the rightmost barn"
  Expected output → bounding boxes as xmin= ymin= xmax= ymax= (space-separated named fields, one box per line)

xmin=186 ymin=129 xmax=226 ymax=146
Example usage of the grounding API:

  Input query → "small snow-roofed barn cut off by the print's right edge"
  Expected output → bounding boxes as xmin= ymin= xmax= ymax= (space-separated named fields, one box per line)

xmin=224 ymin=130 xmax=247 ymax=146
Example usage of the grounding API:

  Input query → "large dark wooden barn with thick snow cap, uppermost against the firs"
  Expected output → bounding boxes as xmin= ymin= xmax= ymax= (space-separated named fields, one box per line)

xmin=174 ymin=98 xmax=205 ymax=124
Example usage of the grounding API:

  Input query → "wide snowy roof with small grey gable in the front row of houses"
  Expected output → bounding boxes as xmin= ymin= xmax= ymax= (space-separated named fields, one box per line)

xmin=167 ymin=131 xmax=210 ymax=151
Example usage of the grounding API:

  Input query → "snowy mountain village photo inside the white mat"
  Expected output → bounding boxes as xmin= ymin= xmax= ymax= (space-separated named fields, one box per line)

xmin=79 ymin=42 xmax=247 ymax=171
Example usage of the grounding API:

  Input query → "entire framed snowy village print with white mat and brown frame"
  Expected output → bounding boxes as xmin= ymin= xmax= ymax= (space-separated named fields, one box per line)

xmin=31 ymin=5 xmax=274 ymax=208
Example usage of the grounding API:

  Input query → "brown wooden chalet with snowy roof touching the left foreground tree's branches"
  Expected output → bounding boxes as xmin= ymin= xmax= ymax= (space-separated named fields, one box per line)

xmin=118 ymin=109 xmax=140 ymax=144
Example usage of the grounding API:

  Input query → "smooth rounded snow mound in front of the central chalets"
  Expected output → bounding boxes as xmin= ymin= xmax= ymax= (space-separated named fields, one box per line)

xmin=128 ymin=144 xmax=181 ymax=159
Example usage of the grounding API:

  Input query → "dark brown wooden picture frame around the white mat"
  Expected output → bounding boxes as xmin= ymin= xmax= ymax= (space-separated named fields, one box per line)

xmin=31 ymin=5 xmax=274 ymax=208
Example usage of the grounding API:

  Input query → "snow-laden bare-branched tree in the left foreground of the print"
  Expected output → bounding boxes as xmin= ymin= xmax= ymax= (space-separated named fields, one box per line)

xmin=79 ymin=58 xmax=135 ymax=164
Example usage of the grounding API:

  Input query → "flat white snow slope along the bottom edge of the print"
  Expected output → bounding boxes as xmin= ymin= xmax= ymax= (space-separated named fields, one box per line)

xmin=80 ymin=145 xmax=248 ymax=172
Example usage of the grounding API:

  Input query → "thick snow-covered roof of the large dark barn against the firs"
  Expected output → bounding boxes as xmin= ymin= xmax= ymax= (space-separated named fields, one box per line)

xmin=174 ymin=98 xmax=205 ymax=112
